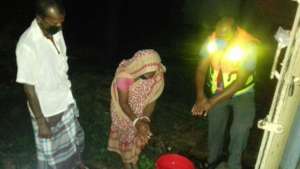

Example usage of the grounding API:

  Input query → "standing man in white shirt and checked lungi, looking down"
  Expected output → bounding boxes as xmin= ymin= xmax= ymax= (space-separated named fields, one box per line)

xmin=16 ymin=0 xmax=86 ymax=169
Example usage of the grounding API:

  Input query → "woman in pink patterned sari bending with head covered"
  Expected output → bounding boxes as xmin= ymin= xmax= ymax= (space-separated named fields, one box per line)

xmin=108 ymin=49 xmax=166 ymax=169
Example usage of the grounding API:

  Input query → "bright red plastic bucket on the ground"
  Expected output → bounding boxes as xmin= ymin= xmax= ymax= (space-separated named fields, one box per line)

xmin=155 ymin=154 xmax=196 ymax=169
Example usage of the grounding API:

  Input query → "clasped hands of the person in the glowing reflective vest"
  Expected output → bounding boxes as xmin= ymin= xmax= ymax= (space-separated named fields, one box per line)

xmin=192 ymin=97 xmax=213 ymax=117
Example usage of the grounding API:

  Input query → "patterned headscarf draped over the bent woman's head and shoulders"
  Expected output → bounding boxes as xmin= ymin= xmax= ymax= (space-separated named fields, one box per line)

xmin=111 ymin=49 xmax=166 ymax=117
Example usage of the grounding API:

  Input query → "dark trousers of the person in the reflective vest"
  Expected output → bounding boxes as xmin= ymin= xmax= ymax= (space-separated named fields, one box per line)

xmin=208 ymin=92 xmax=255 ymax=169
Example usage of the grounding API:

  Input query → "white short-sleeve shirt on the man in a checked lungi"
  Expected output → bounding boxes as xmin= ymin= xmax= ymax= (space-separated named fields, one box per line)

xmin=16 ymin=20 xmax=75 ymax=117
